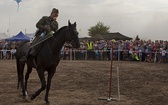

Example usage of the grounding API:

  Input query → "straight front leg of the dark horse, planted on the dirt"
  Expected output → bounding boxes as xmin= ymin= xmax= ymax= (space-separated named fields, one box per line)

xmin=45 ymin=69 xmax=56 ymax=104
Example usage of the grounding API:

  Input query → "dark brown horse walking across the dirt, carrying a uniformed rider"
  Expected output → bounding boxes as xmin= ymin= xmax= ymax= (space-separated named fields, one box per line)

xmin=15 ymin=21 xmax=80 ymax=105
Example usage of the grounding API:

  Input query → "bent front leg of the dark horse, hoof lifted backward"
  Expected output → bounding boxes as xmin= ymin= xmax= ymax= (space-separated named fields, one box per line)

xmin=30 ymin=70 xmax=46 ymax=100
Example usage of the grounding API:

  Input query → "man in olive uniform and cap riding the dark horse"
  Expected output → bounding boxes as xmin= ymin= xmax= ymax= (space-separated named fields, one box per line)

xmin=20 ymin=8 xmax=59 ymax=62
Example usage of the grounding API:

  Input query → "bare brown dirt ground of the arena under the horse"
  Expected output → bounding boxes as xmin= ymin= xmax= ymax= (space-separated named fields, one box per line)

xmin=0 ymin=60 xmax=168 ymax=105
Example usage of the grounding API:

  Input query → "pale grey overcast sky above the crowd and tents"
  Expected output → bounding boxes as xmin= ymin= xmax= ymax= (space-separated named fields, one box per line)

xmin=0 ymin=0 xmax=168 ymax=40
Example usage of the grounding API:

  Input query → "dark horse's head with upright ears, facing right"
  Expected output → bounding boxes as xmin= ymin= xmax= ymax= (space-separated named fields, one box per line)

xmin=66 ymin=21 xmax=80 ymax=48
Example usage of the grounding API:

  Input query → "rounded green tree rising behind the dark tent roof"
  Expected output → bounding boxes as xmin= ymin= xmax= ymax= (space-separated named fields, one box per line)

xmin=88 ymin=22 xmax=110 ymax=37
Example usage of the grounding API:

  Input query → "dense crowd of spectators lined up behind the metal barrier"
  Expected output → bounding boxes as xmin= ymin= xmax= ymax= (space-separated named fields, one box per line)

xmin=0 ymin=36 xmax=168 ymax=63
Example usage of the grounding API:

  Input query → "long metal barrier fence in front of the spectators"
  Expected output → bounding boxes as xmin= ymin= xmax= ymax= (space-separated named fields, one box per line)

xmin=0 ymin=49 xmax=168 ymax=63
